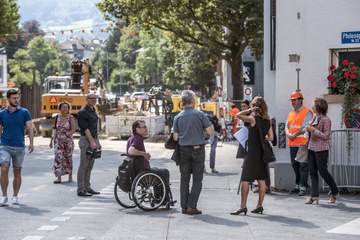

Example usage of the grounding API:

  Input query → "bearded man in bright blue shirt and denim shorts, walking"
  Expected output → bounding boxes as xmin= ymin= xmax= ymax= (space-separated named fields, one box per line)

xmin=0 ymin=89 xmax=34 ymax=206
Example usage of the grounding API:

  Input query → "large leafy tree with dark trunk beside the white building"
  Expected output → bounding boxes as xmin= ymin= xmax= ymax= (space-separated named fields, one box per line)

xmin=97 ymin=0 xmax=263 ymax=99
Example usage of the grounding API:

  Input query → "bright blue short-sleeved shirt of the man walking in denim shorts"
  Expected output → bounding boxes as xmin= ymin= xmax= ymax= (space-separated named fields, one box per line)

xmin=0 ymin=106 xmax=31 ymax=147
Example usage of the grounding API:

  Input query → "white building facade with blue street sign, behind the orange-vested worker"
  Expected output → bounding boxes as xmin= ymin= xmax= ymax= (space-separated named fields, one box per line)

xmin=264 ymin=0 xmax=360 ymax=189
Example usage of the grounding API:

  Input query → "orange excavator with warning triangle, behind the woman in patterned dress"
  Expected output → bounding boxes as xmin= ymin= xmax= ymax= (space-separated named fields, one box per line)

xmin=39 ymin=59 xmax=91 ymax=137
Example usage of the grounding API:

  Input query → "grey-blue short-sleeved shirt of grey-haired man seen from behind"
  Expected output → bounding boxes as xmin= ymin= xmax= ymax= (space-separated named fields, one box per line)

xmin=173 ymin=107 xmax=211 ymax=146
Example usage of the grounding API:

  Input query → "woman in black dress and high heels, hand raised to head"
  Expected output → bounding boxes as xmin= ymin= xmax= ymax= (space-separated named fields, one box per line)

xmin=230 ymin=97 xmax=273 ymax=215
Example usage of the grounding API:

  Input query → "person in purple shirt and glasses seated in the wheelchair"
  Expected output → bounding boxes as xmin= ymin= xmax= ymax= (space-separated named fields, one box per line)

xmin=122 ymin=120 xmax=176 ymax=210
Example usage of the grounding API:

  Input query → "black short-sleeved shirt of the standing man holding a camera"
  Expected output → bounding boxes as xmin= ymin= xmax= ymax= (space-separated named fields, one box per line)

xmin=78 ymin=105 xmax=98 ymax=138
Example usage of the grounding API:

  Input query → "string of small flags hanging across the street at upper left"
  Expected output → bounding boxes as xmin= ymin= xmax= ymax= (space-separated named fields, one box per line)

xmin=0 ymin=23 xmax=136 ymax=42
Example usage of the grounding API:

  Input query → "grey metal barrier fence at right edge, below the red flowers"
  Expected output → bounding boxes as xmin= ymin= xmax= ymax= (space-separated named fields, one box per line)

xmin=323 ymin=129 xmax=360 ymax=190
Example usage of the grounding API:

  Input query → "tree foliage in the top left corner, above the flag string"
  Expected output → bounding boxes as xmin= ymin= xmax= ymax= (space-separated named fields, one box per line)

xmin=0 ymin=0 xmax=20 ymax=35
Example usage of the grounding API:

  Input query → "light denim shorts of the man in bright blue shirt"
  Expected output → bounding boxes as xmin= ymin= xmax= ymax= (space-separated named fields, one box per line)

xmin=0 ymin=146 xmax=25 ymax=168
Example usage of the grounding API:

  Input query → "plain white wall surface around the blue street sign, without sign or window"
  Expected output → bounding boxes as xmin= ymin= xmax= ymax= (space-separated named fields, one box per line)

xmin=264 ymin=0 xmax=360 ymax=189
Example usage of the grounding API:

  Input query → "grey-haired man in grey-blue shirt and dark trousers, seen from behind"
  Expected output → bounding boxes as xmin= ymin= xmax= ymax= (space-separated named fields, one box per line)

xmin=173 ymin=90 xmax=213 ymax=215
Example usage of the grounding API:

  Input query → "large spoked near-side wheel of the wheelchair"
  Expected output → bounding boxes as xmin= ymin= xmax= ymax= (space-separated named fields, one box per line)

xmin=131 ymin=172 xmax=166 ymax=211
